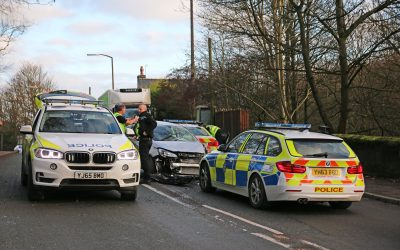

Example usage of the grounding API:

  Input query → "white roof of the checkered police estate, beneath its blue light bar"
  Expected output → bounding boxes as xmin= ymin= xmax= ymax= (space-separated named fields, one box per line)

xmin=250 ymin=129 xmax=343 ymax=141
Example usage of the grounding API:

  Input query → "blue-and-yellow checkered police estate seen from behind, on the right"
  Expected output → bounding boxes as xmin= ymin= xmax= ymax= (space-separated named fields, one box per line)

xmin=200 ymin=123 xmax=365 ymax=209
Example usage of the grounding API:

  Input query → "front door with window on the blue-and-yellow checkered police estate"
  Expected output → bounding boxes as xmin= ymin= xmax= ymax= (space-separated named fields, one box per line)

xmin=215 ymin=132 xmax=250 ymax=185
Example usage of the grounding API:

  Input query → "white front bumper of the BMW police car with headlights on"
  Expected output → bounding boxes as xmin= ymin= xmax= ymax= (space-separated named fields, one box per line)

xmin=32 ymin=158 xmax=140 ymax=190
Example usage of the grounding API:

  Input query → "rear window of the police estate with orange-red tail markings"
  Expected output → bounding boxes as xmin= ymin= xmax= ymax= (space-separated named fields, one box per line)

xmin=286 ymin=139 xmax=350 ymax=159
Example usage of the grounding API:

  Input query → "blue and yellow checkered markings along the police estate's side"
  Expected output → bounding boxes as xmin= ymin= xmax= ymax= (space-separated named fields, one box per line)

xmin=206 ymin=153 xmax=280 ymax=187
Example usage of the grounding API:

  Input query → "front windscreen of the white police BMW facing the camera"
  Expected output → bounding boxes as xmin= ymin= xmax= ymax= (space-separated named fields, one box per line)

xmin=39 ymin=110 xmax=121 ymax=134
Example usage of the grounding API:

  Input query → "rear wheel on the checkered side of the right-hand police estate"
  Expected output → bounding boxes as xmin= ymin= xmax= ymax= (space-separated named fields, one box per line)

xmin=249 ymin=174 xmax=271 ymax=208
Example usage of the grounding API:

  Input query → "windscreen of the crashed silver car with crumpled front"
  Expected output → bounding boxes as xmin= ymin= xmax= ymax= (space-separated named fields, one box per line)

xmin=154 ymin=124 xmax=197 ymax=142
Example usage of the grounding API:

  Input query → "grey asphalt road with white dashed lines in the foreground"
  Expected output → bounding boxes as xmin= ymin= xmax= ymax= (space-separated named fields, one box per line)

xmin=0 ymin=155 xmax=400 ymax=249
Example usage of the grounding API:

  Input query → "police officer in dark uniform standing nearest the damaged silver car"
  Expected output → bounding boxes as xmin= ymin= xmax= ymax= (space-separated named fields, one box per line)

xmin=134 ymin=104 xmax=157 ymax=184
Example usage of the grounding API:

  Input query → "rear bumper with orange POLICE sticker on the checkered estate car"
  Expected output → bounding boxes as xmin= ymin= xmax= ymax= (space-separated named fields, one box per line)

xmin=265 ymin=185 xmax=364 ymax=201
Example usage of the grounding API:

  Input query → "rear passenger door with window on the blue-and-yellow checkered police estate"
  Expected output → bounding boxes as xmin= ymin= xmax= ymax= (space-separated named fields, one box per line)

xmin=238 ymin=132 xmax=268 ymax=188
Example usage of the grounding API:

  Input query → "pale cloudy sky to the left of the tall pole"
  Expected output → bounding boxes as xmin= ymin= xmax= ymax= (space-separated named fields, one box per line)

xmin=0 ymin=0 xmax=195 ymax=97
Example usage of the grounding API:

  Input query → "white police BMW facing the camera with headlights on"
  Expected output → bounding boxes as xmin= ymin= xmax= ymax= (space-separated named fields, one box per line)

xmin=20 ymin=91 xmax=140 ymax=200
